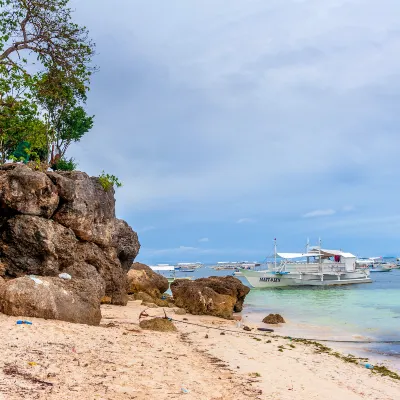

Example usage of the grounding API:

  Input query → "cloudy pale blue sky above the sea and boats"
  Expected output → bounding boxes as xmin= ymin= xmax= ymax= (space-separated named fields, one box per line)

xmin=70 ymin=0 xmax=400 ymax=263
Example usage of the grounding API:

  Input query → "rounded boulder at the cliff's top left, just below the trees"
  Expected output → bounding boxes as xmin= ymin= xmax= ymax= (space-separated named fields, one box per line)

xmin=0 ymin=165 xmax=60 ymax=218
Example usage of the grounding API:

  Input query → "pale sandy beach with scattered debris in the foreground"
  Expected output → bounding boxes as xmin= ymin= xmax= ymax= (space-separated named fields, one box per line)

xmin=0 ymin=302 xmax=400 ymax=400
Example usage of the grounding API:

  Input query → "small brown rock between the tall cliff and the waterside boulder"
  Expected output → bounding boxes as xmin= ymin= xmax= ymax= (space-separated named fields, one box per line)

xmin=127 ymin=263 xmax=169 ymax=299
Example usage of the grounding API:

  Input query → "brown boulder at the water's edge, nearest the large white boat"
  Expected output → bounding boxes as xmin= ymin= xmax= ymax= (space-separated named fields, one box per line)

xmin=171 ymin=276 xmax=250 ymax=319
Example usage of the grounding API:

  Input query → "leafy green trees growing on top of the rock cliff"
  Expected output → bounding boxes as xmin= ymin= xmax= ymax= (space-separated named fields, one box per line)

xmin=0 ymin=0 xmax=95 ymax=162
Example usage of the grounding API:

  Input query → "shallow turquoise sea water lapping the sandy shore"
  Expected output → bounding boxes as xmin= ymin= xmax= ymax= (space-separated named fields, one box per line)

xmin=169 ymin=266 xmax=400 ymax=371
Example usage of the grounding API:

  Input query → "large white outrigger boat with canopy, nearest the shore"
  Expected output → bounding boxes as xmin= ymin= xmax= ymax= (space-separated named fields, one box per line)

xmin=240 ymin=244 xmax=372 ymax=288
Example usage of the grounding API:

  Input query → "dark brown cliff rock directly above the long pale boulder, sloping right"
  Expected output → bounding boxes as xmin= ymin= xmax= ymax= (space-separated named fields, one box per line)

xmin=0 ymin=215 xmax=127 ymax=305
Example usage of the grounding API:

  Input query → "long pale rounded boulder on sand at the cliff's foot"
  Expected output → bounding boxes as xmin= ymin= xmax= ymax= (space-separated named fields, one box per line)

xmin=0 ymin=276 xmax=104 ymax=325
